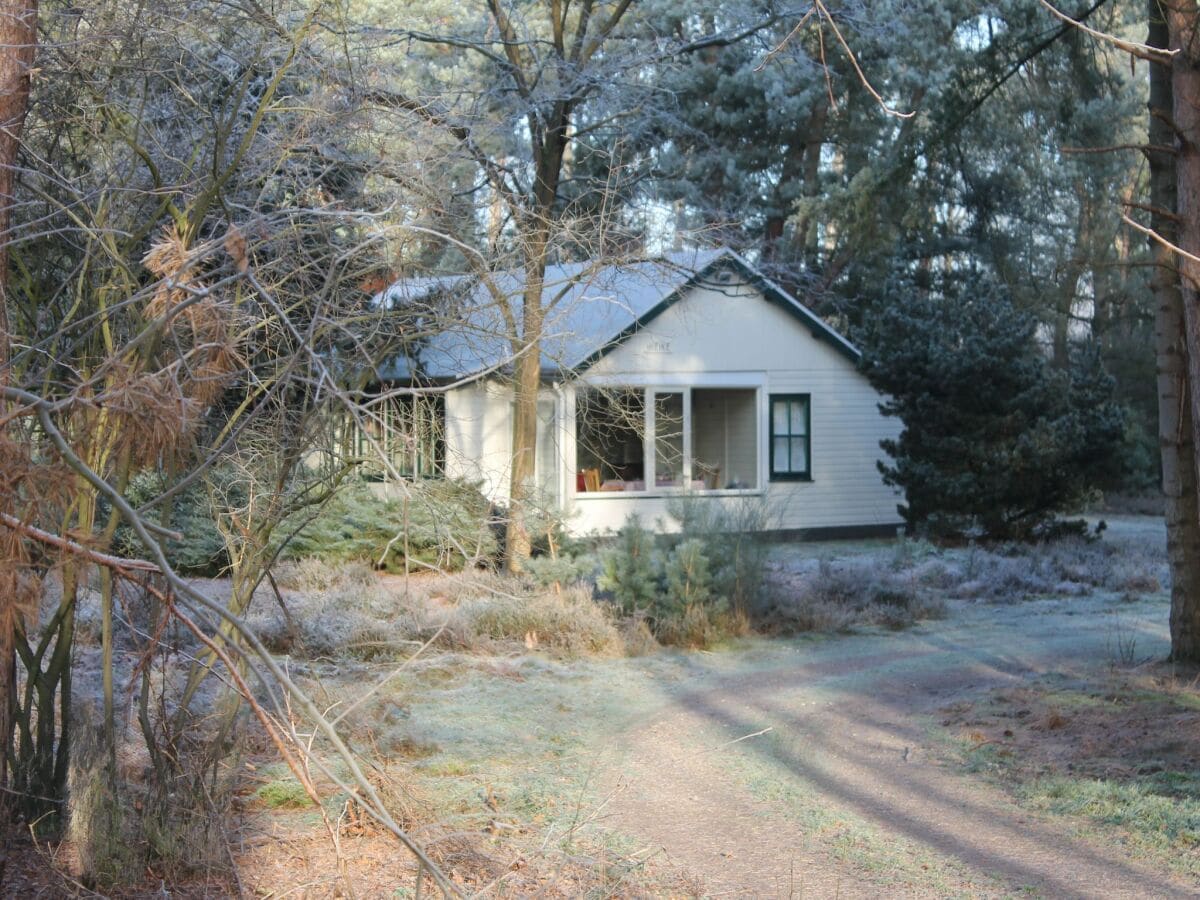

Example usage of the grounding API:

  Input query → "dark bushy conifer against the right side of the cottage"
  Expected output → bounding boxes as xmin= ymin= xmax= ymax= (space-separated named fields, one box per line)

xmin=863 ymin=281 xmax=1126 ymax=539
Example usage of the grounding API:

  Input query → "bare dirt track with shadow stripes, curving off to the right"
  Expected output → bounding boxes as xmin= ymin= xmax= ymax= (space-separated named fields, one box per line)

xmin=600 ymin=601 xmax=1200 ymax=898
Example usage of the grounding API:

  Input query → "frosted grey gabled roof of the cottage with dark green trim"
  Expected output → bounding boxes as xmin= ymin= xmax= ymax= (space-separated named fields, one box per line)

xmin=378 ymin=248 xmax=860 ymax=382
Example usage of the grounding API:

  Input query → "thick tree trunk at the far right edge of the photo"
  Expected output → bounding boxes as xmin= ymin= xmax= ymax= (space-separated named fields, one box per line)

xmin=1147 ymin=0 xmax=1200 ymax=662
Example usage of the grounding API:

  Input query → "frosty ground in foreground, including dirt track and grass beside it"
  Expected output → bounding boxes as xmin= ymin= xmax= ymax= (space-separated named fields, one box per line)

xmin=11 ymin=517 xmax=1200 ymax=898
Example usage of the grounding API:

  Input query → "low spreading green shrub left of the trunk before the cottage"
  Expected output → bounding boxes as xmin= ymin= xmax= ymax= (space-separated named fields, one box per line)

xmin=283 ymin=479 xmax=497 ymax=570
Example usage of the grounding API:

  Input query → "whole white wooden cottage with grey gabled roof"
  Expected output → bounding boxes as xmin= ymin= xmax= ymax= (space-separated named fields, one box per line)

xmin=369 ymin=250 xmax=900 ymax=536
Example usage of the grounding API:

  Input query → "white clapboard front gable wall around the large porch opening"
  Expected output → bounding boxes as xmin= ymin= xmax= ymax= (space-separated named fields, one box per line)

xmin=563 ymin=284 xmax=900 ymax=534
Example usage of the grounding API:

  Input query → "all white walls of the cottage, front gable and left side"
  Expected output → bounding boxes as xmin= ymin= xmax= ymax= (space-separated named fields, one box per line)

xmin=445 ymin=278 xmax=900 ymax=534
